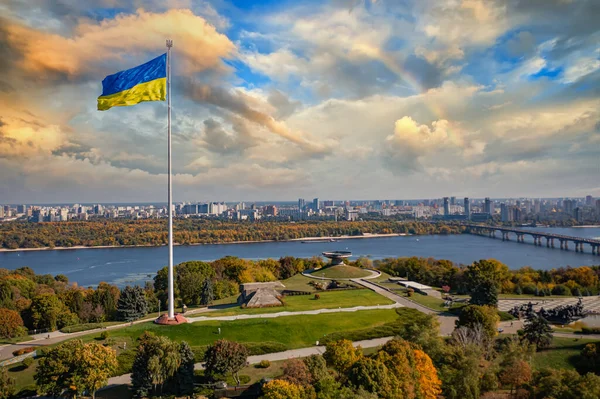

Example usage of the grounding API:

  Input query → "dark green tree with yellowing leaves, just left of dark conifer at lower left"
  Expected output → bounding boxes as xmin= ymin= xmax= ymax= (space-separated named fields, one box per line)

xmin=131 ymin=331 xmax=181 ymax=397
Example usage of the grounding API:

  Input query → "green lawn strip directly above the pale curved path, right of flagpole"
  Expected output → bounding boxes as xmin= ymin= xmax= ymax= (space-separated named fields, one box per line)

xmin=202 ymin=289 xmax=394 ymax=317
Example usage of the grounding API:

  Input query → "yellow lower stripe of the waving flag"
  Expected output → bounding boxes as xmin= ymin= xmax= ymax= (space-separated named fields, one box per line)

xmin=98 ymin=78 xmax=167 ymax=111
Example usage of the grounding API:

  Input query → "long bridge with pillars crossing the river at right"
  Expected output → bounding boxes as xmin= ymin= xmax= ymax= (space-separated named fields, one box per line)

xmin=465 ymin=224 xmax=600 ymax=255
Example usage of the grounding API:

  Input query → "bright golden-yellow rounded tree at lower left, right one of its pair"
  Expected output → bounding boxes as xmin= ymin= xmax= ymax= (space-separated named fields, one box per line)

xmin=73 ymin=343 xmax=118 ymax=398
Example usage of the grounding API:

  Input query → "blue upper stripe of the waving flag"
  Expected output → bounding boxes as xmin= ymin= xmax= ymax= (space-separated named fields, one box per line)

xmin=102 ymin=53 xmax=167 ymax=96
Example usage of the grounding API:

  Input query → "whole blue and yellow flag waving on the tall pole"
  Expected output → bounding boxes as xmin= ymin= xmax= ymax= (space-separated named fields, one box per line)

xmin=98 ymin=53 xmax=167 ymax=111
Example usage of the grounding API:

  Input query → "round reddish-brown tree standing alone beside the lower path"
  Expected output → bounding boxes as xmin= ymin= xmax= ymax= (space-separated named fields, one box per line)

xmin=204 ymin=339 xmax=248 ymax=385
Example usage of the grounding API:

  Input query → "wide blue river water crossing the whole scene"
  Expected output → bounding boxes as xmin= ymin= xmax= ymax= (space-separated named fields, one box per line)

xmin=0 ymin=227 xmax=600 ymax=286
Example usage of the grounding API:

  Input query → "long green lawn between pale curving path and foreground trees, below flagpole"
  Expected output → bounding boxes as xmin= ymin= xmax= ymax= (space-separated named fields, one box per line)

xmin=78 ymin=309 xmax=398 ymax=349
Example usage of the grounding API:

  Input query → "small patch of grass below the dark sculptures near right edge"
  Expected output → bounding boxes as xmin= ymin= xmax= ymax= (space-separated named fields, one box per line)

xmin=531 ymin=337 xmax=598 ymax=370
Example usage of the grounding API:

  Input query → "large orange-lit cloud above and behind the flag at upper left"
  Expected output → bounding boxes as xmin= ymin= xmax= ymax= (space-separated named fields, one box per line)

xmin=5 ymin=9 xmax=235 ymax=78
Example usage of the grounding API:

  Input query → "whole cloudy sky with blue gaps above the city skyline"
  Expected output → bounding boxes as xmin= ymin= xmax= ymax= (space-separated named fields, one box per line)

xmin=0 ymin=0 xmax=600 ymax=203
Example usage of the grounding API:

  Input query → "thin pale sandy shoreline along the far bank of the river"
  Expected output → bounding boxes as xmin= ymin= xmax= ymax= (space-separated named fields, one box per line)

xmin=0 ymin=233 xmax=410 ymax=252
